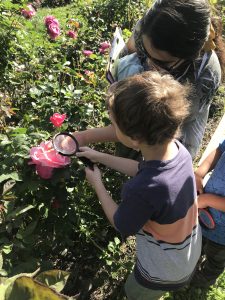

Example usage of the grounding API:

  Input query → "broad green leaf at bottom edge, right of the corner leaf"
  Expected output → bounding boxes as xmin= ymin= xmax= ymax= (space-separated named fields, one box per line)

xmin=35 ymin=270 xmax=70 ymax=292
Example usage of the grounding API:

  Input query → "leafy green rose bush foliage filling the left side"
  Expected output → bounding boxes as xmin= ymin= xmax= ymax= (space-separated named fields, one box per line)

xmin=0 ymin=1 xmax=141 ymax=296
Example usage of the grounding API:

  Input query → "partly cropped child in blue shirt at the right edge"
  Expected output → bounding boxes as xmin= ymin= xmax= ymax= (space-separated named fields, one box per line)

xmin=191 ymin=140 xmax=225 ymax=288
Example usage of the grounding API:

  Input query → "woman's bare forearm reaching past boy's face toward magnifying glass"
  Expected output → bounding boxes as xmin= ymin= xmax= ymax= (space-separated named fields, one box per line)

xmin=73 ymin=125 xmax=118 ymax=146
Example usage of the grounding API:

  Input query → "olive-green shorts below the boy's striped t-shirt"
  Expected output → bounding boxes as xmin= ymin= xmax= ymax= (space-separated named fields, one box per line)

xmin=125 ymin=272 xmax=166 ymax=300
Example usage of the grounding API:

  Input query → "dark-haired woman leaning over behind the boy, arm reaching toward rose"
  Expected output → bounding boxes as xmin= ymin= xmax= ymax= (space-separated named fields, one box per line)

xmin=75 ymin=0 xmax=224 ymax=158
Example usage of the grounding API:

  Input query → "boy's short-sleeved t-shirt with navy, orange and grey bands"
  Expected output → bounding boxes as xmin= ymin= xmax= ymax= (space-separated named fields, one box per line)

xmin=114 ymin=141 xmax=201 ymax=290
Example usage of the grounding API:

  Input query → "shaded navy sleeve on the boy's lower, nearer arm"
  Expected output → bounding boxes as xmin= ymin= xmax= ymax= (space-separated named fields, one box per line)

xmin=114 ymin=186 xmax=159 ymax=238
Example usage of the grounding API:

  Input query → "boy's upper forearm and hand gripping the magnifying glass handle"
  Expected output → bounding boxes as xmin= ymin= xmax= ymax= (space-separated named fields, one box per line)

xmin=76 ymin=147 xmax=138 ymax=176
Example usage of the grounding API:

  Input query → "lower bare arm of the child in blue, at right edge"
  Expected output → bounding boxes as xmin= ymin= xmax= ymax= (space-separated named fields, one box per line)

xmin=198 ymin=193 xmax=225 ymax=212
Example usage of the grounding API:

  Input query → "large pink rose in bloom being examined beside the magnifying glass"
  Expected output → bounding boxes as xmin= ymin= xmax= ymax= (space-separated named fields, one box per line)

xmin=29 ymin=141 xmax=70 ymax=179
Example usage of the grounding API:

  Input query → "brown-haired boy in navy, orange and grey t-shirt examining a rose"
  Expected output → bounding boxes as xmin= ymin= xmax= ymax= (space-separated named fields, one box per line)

xmin=77 ymin=72 xmax=201 ymax=300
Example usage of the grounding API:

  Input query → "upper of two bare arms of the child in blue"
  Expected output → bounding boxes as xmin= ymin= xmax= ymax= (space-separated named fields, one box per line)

xmin=195 ymin=147 xmax=222 ymax=194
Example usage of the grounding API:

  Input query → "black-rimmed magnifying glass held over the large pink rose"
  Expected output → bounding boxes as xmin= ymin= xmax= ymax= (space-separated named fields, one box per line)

xmin=52 ymin=132 xmax=94 ymax=170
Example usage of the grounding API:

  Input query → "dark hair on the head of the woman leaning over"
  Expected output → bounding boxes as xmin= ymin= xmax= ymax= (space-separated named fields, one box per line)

xmin=141 ymin=0 xmax=211 ymax=59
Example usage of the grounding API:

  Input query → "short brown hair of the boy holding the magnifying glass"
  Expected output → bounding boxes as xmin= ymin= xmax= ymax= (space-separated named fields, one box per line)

xmin=108 ymin=71 xmax=190 ymax=145
